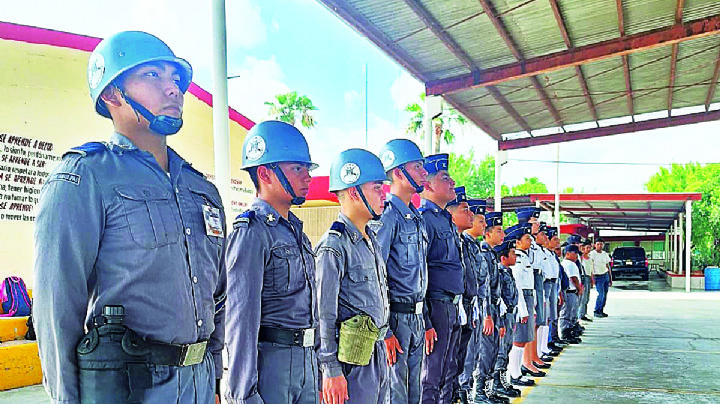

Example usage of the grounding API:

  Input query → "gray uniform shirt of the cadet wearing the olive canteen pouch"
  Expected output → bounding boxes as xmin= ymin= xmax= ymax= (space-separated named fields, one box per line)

xmin=316 ymin=213 xmax=390 ymax=377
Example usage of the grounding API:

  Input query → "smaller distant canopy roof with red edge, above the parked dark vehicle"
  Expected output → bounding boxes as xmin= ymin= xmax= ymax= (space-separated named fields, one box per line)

xmin=524 ymin=192 xmax=702 ymax=232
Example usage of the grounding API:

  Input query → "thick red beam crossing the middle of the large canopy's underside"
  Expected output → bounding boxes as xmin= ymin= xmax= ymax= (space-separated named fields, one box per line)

xmin=425 ymin=15 xmax=720 ymax=95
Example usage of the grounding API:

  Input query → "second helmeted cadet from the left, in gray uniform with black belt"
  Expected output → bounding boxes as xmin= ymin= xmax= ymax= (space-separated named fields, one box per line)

xmin=225 ymin=121 xmax=318 ymax=404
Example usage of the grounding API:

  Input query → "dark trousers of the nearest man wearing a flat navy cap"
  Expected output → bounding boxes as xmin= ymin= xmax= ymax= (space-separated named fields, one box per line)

xmin=422 ymin=299 xmax=461 ymax=404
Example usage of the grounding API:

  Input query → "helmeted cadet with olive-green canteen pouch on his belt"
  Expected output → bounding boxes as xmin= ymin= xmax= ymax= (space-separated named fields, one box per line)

xmin=316 ymin=149 xmax=390 ymax=404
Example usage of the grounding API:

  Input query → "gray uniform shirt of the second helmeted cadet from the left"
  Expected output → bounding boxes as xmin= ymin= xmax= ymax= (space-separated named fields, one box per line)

xmin=225 ymin=198 xmax=317 ymax=400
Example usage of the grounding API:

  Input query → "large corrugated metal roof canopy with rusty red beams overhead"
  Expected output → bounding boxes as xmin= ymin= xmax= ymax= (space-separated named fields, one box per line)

xmin=318 ymin=0 xmax=720 ymax=150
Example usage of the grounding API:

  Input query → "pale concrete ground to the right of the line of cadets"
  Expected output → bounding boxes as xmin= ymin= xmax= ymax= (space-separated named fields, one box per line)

xmin=0 ymin=274 xmax=720 ymax=404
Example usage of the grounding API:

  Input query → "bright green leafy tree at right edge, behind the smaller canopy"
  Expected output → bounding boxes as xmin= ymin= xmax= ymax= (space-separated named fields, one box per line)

xmin=645 ymin=163 xmax=720 ymax=269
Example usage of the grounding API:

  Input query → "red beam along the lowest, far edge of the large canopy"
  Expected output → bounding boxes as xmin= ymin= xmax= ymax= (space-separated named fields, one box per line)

xmin=498 ymin=110 xmax=720 ymax=150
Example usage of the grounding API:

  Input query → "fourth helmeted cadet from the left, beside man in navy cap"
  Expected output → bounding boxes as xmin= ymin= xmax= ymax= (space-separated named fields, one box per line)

xmin=377 ymin=139 xmax=428 ymax=404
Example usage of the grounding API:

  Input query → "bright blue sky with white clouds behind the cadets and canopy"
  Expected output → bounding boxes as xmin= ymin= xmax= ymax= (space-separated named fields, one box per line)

xmin=0 ymin=0 xmax=720 ymax=193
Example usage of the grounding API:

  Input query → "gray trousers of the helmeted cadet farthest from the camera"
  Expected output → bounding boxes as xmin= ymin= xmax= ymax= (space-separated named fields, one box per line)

xmin=389 ymin=312 xmax=425 ymax=404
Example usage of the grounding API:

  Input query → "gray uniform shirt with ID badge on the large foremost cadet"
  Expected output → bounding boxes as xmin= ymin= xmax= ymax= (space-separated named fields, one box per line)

xmin=33 ymin=133 xmax=226 ymax=402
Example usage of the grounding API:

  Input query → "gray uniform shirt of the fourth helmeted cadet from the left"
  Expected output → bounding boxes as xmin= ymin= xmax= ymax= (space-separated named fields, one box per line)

xmin=377 ymin=194 xmax=428 ymax=303
